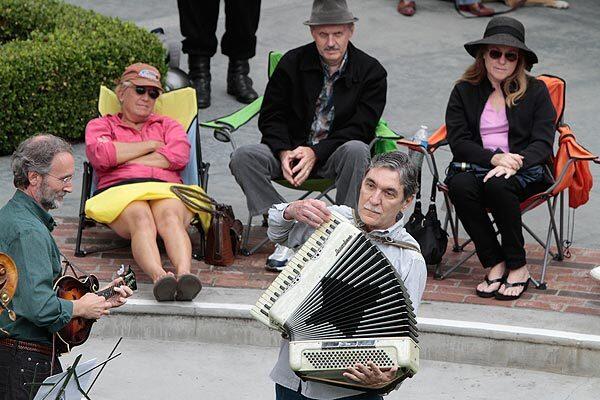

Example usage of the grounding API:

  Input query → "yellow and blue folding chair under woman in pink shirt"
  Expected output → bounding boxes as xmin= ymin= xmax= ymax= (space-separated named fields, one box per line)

xmin=75 ymin=86 xmax=210 ymax=259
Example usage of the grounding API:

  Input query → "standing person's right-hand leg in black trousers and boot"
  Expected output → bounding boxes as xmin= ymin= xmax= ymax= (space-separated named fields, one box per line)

xmin=221 ymin=0 xmax=260 ymax=104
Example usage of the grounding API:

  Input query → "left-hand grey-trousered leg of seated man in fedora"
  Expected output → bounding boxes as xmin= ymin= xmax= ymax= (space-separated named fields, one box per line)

xmin=229 ymin=143 xmax=286 ymax=216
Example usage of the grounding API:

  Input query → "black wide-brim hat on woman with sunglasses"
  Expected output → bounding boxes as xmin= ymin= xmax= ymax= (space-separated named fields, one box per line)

xmin=465 ymin=17 xmax=538 ymax=68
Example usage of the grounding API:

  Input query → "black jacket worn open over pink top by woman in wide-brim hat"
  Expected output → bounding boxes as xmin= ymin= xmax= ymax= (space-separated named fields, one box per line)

xmin=446 ymin=77 xmax=556 ymax=169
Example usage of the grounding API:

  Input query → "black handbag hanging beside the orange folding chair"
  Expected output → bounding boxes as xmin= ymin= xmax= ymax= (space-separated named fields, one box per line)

xmin=404 ymin=173 xmax=448 ymax=264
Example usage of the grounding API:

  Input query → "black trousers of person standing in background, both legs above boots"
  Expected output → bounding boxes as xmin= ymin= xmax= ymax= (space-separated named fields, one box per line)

xmin=177 ymin=0 xmax=260 ymax=60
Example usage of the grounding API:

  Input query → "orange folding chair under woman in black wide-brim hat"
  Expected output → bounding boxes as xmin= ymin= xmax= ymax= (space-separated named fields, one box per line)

xmin=397 ymin=75 xmax=598 ymax=289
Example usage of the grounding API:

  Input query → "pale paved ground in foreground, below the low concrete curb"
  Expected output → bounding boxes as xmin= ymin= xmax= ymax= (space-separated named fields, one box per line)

xmin=62 ymin=339 xmax=600 ymax=400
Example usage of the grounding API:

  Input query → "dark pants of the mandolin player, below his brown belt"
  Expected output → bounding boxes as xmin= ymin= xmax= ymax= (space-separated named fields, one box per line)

xmin=0 ymin=345 xmax=62 ymax=400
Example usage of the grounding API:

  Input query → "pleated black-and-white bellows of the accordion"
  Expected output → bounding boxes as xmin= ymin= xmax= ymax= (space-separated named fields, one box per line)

xmin=284 ymin=234 xmax=417 ymax=341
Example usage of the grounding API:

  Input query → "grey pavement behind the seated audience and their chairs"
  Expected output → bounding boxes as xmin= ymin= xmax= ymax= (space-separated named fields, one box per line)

xmin=0 ymin=0 xmax=600 ymax=248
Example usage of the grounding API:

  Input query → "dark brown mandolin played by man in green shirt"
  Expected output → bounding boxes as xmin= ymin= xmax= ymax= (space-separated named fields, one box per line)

xmin=54 ymin=265 xmax=137 ymax=353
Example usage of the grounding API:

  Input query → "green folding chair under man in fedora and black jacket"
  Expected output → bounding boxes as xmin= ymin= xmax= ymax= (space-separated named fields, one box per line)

xmin=200 ymin=51 xmax=402 ymax=256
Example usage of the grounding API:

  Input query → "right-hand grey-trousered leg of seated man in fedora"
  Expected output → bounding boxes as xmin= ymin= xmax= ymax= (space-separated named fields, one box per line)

xmin=316 ymin=140 xmax=371 ymax=208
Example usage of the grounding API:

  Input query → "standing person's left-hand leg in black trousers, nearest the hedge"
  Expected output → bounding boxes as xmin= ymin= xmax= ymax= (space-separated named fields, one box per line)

xmin=177 ymin=0 xmax=219 ymax=108
